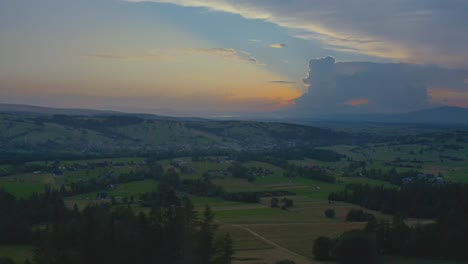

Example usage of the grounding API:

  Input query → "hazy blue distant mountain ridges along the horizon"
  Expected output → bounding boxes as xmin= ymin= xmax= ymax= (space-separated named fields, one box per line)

xmin=0 ymin=104 xmax=468 ymax=125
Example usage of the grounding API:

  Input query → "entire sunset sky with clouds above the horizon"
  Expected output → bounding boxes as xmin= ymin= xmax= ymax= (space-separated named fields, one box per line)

xmin=0 ymin=0 xmax=468 ymax=116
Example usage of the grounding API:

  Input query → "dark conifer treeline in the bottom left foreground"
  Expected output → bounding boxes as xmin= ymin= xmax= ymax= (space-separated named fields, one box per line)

xmin=0 ymin=189 xmax=233 ymax=264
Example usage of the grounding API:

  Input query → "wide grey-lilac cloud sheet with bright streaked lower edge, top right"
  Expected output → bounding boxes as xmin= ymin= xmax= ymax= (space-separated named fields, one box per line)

xmin=127 ymin=0 xmax=468 ymax=67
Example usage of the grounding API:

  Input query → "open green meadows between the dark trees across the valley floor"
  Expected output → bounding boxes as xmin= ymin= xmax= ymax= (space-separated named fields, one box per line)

xmin=0 ymin=134 xmax=468 ymax=264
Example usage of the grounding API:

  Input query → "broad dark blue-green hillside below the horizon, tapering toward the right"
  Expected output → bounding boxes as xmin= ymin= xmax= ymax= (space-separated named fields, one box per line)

xmin=0 ymin=113 xmax=356 ymax=157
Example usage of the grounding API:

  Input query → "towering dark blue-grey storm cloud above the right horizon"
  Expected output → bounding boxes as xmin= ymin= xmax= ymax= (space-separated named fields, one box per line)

xmin=295 ymin=57 xmax=468 ymax=113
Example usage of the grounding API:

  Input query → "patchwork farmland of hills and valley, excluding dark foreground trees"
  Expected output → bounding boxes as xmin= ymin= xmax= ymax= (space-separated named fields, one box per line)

xmin=0 ymin=115 xmax=468 ymax=264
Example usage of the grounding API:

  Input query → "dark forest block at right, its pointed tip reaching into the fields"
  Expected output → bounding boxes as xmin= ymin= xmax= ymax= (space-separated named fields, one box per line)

xmin=329 ymin=182 xmax=468 ymax=261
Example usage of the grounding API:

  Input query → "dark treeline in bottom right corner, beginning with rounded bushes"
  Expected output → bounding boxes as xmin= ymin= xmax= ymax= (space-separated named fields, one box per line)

xmin=313 ymin=213 xmax=468 ymax=264
